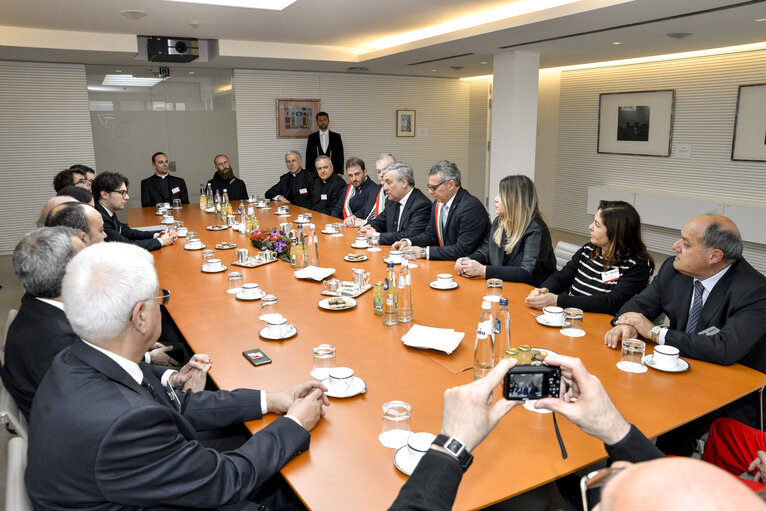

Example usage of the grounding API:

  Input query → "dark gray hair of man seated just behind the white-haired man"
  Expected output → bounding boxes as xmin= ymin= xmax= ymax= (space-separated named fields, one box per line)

xmin=13 ymin=227 xmax=80 ymax=302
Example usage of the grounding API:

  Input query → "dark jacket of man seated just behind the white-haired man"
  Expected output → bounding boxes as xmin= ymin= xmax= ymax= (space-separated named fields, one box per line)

xmin=3 ymin=294 xmax=78 ymax=419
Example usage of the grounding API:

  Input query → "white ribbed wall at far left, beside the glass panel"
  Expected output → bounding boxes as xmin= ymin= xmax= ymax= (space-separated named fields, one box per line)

xmin=0 ymin=62 xmax=94 ymax=254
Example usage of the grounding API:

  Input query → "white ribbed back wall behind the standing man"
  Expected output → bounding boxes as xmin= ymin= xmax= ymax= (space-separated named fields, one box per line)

xmin=234 ymin=69 xmax=487 ymax=199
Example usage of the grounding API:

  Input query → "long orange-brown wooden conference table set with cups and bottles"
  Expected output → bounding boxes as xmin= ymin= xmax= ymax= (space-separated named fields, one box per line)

xmin=128 ymin=202 xmax=766 ymax=510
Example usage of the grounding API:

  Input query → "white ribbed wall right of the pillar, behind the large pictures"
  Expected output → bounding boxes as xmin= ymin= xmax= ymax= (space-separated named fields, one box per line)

xmin=535 ymin=47 xmax=766 ymax=272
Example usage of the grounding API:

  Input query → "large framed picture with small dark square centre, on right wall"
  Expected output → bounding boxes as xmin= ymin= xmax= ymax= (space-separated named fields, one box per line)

xmin=597 ymin=90 xmax=676 ymax=156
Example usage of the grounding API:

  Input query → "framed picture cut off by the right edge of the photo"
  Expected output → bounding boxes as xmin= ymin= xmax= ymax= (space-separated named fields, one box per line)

xmin=731 ymin=83 xmax=766 ymax=161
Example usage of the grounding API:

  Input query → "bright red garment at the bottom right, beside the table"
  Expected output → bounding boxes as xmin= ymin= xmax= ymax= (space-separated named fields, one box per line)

xmin=702 ymin=418 xmax=766 ymax=491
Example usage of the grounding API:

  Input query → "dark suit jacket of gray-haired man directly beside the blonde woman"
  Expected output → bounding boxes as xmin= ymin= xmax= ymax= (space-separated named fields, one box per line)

xmin=408 ymin=188 xmax=490 ymax=261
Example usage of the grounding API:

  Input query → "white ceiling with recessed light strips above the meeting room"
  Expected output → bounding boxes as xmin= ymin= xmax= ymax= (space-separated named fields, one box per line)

xmin=0 ymin=0 xmax=766 ymax=78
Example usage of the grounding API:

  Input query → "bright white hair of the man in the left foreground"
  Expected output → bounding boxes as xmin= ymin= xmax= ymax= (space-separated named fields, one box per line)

xmin=61 ymin=243 xmax=158 ymax=343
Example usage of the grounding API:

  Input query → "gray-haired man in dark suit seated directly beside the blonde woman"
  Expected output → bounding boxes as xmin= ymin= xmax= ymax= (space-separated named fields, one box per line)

xmin=393 ymin=160 xmax=490 ymax=261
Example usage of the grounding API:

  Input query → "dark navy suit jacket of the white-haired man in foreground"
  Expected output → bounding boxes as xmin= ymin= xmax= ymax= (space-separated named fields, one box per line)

xmin=25 ymin=340 xmax=309 ymax=511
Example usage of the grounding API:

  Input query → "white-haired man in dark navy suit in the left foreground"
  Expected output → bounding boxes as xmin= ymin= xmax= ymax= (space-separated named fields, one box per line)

xmin=25 ymin=243 xmax=328 ymax=510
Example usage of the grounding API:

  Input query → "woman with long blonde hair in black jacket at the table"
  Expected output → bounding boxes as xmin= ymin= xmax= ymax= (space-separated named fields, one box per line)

xmin=455 ymin=175 xmax=556 ymax=286
